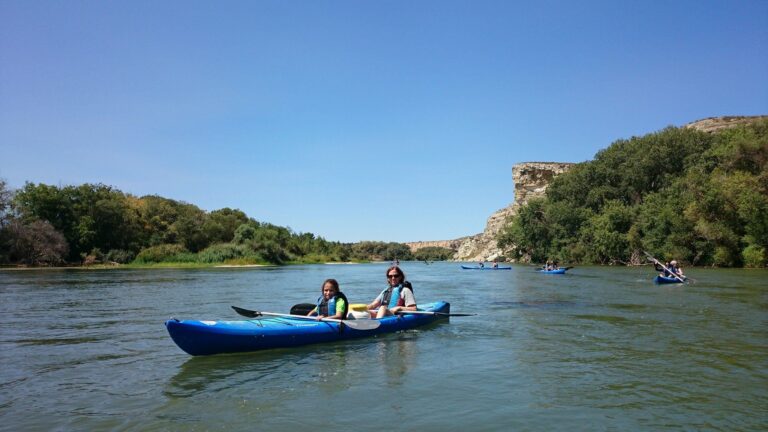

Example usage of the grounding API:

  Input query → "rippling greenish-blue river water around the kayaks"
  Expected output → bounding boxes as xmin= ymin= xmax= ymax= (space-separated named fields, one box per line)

xmin=0 ymin=262 xmax=768 ymax=432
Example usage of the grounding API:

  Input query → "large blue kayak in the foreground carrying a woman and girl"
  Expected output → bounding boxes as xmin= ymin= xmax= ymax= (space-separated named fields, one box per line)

xmin=165 ymin=301 xmax=451 ymax=355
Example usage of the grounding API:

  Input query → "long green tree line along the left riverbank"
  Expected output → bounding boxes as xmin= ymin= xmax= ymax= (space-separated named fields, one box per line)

xmin=0 ymin=179 xmax=456 ymax=265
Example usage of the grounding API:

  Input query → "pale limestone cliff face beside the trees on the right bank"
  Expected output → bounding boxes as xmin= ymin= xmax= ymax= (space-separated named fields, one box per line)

xmin=407 ymin=162 xmax=574 ymax=261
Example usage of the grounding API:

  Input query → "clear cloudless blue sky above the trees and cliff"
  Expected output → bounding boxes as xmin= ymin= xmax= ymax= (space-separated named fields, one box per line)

xmin=0 ymin=0 xmax=768 ymax=242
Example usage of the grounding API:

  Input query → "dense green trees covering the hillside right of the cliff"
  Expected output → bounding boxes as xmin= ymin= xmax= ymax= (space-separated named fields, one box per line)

xmin=497 ymin=120 xmax=768 ymax=267
